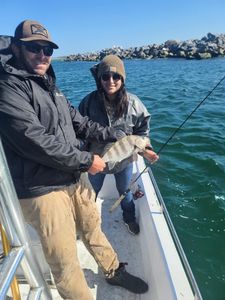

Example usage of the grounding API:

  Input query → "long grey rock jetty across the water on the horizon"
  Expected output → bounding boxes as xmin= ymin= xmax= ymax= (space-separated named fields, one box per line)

xmin=61 ymin=33 xmax=225 ymax=61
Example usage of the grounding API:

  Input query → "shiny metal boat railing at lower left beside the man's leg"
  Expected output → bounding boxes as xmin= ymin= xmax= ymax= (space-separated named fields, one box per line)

xmin=0 ymin=139 xmax=52 ymax=300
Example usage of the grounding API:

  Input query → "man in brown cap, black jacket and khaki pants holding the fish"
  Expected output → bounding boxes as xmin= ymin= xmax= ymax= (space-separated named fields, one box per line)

xmin=0 ymin=20 xmax=148 ymax=300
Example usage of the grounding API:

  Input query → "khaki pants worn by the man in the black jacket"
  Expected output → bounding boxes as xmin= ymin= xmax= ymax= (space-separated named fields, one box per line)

xmin=20 ymin=174 xmax=119 ymax=300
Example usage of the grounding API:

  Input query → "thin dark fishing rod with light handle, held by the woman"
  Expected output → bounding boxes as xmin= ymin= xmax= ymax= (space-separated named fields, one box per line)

xmin=109 ymin=76 xmax=225 ymax=212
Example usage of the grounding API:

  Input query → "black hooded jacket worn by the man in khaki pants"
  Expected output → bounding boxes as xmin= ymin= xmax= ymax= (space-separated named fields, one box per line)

xmin=0 ymin=36 xmax=117 ymax=198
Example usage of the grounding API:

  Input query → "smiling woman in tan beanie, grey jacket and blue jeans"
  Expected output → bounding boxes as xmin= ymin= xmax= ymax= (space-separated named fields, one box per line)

xmin=79 ymin=55 xmax=158 ymax=235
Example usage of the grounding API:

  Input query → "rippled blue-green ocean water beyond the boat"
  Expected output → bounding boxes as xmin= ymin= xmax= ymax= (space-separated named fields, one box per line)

xmin=53 ymin=58 xmax=225 ymax=300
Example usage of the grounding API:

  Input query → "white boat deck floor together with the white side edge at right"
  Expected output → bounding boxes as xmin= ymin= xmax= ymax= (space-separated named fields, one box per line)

xmin=0 ymin=159 xmax=202 ymax=300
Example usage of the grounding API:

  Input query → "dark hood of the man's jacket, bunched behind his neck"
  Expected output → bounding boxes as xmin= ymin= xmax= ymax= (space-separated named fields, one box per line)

xmin=0 ymin=35 xmax=55 ymax=82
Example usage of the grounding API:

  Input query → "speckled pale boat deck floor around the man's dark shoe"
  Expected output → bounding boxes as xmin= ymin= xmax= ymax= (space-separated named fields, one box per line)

xmin=78 ymin=198 xmax=142 ymax=300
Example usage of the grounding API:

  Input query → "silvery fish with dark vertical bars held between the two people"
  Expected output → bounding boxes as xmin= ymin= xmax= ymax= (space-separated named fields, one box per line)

xmin=102 ymin=135 xmax=150 ymax=173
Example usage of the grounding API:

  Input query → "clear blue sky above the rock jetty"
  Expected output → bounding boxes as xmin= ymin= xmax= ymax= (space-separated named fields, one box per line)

xmin=0 ymin=0 xmax=225 ymax=56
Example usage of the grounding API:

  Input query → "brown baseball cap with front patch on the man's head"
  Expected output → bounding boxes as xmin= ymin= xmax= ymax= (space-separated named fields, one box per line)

xmin=14 ymin=20 xmax=59 ymax=49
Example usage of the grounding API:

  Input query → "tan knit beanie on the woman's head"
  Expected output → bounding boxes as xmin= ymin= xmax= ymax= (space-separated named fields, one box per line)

xmin=97 ymin=54 xmax=126 ymax=82
